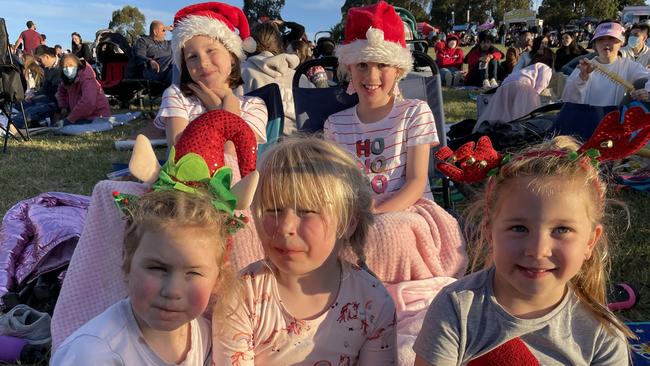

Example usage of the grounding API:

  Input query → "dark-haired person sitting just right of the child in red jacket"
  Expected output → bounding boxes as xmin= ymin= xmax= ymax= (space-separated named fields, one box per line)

xmin=464 ymin=31 xmax=503 ymax=88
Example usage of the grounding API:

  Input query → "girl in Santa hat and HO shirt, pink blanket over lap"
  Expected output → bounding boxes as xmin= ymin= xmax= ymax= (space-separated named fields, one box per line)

xmin=324 ymin=1 xmax=467 ymax=283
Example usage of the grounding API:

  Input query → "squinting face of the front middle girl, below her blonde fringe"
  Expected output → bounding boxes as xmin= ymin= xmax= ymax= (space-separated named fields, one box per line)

xmin=258 ymin=207 xmax=339 ymax=276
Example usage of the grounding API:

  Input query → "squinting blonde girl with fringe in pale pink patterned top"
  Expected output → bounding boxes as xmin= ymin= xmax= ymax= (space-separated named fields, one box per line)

xmin=214 ymin=137 xmax=396 ymax=365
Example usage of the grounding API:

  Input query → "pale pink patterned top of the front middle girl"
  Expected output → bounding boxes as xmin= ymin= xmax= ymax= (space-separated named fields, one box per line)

xmin=214 ymin=261 xmax=397 ymax=366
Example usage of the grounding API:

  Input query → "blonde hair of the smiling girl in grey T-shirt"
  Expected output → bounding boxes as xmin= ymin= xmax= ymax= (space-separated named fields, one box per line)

xmin=467 ymin=136 xmax=635 ymax=337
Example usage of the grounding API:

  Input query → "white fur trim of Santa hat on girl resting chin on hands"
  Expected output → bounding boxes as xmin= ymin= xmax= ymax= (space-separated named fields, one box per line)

xmin=172 ymin=15 xmax=248 ymax=68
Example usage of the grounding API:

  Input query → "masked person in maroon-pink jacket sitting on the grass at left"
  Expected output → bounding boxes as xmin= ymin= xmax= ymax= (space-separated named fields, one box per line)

xmin=56 ymin=53 xmax=111 ymax=125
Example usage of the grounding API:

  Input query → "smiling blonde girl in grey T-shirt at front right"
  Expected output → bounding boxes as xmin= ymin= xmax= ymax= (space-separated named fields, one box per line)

xmin=413 ymin=137 xmax=631 ymax=366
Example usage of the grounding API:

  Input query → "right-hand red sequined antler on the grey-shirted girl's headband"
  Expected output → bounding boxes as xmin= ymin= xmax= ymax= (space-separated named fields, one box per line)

xmin=578 ymin=107 xmax=650 ymax=161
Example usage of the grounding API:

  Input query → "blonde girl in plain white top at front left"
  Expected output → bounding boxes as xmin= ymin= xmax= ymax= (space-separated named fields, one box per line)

xmin=51 ymin=190 xmax=236 ymax=365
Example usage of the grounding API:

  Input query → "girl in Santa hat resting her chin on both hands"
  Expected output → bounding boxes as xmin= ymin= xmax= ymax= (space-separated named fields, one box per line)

xmin=154 ymin=2 xmax=267 ymax=155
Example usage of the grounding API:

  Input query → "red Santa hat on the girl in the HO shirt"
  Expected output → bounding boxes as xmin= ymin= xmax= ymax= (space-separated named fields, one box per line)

xmin=336 ymin=1 xmax=413 ymax=75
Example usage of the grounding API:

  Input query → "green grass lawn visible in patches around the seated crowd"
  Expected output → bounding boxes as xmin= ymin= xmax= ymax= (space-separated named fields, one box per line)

xmin=0 ymin=83 xmax=650 ymax=321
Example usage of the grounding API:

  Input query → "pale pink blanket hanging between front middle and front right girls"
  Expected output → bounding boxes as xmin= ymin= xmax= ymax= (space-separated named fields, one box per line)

xmin=386 ymin=277 xmax=456 ymax=366
